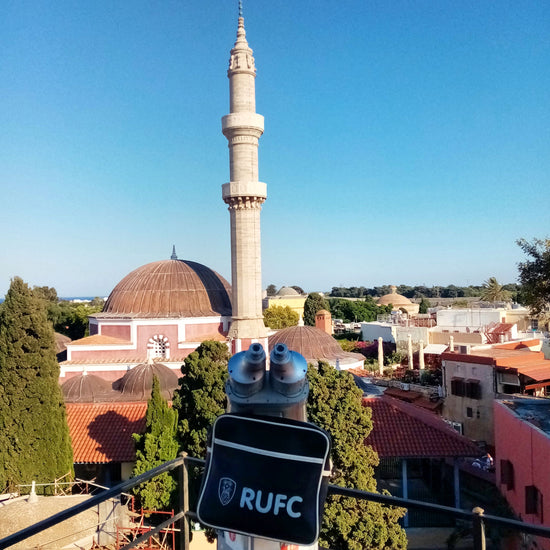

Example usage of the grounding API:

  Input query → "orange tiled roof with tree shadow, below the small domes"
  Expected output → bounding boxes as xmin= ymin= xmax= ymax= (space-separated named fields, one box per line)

xmin=67 ymin=402 xmax=147 ymax=464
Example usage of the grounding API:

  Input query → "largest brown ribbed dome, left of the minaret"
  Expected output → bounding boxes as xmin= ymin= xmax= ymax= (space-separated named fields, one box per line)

xmin=100 ymin=255 xmax=231 ymax=318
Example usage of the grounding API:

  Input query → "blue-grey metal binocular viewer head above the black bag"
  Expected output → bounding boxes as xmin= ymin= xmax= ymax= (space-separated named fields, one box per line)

xmin=225 ymin=343 xmax=309 ymax=421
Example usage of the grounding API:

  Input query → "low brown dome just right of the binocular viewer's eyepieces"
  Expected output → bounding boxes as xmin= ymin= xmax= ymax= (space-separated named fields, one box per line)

xmin=269 ymin=326 xmax=365 ymax=369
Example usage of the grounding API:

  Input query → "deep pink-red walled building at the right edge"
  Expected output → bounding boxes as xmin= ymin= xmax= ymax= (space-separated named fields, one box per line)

xmin=494 ymin=397 xmax=550 ymax=550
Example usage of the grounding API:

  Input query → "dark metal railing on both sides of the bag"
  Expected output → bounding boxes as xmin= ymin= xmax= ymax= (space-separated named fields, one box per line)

xmin=0 ymin=453 xmax=550 ymax=550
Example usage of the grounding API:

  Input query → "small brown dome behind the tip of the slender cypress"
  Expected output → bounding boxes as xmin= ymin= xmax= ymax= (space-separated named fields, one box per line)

xmin=117 ymin=363 xmax=178 ymax=401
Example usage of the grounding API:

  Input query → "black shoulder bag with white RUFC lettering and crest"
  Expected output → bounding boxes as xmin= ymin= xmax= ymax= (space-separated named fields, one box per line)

xmin=197 ymin=414 xmax=330 ymax=545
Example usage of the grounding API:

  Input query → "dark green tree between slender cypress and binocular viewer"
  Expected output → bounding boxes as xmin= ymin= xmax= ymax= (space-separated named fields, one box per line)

xmin=173 ymin=341 xmax=229 ymax=458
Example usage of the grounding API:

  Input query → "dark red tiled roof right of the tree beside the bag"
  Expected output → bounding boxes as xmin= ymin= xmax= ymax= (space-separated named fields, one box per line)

xmin=363 ymin=397 xmax=480 ymax=458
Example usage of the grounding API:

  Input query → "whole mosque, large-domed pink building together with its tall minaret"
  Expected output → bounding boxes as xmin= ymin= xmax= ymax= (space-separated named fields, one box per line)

xmin=60 ymin=5 xmax=268 ymax=381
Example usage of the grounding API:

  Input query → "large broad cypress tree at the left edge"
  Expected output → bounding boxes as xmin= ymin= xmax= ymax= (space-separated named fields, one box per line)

xmin=0 ymin=277 xmax=73 ymax=491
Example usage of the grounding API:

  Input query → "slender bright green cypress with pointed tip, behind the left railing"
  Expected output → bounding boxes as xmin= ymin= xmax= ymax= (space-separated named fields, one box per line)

xmin=133 ymin=376 xmax=178 ymax=510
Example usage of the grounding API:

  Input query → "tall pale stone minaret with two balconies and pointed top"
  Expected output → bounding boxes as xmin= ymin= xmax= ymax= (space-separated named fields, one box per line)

xmin=222 ymin=2 xmax=267 ymax=352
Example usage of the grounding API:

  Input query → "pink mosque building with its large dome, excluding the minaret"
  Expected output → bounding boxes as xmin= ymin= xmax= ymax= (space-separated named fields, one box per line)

xmin=60 ymin=254 xmax=231 ymax=382
